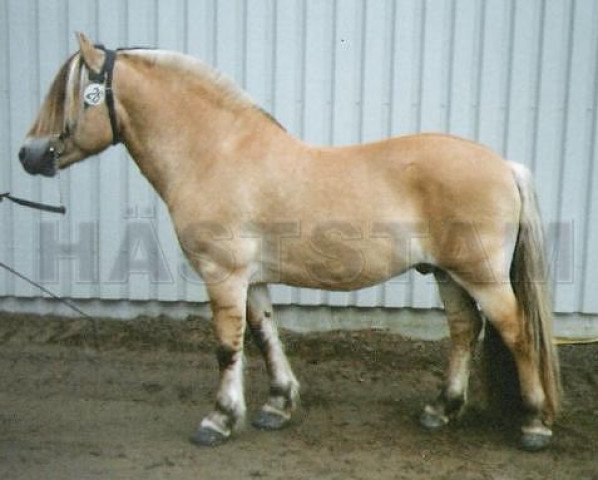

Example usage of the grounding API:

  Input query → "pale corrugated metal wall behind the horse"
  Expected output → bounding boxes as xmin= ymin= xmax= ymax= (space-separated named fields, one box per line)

xmin=0 ymin=0 xmax=598 ymax=314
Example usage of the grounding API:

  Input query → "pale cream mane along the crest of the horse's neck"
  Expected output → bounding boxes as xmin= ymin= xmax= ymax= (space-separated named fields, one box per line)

xmin=122 ymin=49 xmax=284 ymax=130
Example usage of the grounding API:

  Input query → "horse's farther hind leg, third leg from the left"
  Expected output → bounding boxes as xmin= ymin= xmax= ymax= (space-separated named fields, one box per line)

xmin=420 ymin=271 xmax=482 ymax=429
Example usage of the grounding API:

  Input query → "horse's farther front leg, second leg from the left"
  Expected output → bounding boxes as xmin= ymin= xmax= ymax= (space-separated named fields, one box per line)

xmin=247 ymin=285 xmax=299 ymax=430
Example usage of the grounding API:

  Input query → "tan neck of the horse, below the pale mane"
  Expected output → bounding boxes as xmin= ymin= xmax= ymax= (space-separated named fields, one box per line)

xmin=119 ymin=59 xmax=265 ymax=204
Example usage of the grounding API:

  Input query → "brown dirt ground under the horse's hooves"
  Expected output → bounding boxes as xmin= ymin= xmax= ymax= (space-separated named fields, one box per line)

xmin=0 ymin=315 xmax=598 ymax=480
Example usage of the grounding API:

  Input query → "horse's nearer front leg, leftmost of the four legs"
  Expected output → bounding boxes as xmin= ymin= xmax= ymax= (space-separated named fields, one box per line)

xmin=191 ymin=275 xmax=247 ymax=446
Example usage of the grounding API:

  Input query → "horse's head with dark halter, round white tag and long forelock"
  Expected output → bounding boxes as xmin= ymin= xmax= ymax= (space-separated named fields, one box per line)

xmin=19 ymin=33 xmax=118 ymax=177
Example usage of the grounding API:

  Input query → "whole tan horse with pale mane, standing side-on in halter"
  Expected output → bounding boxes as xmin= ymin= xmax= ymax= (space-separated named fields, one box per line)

xmin=18 ymin=33 xmax=561 ymax=451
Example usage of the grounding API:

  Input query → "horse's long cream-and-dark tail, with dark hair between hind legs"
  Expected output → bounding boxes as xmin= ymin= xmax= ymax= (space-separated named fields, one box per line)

xmin=484 ymin=162 xmax=561 ymax=423
